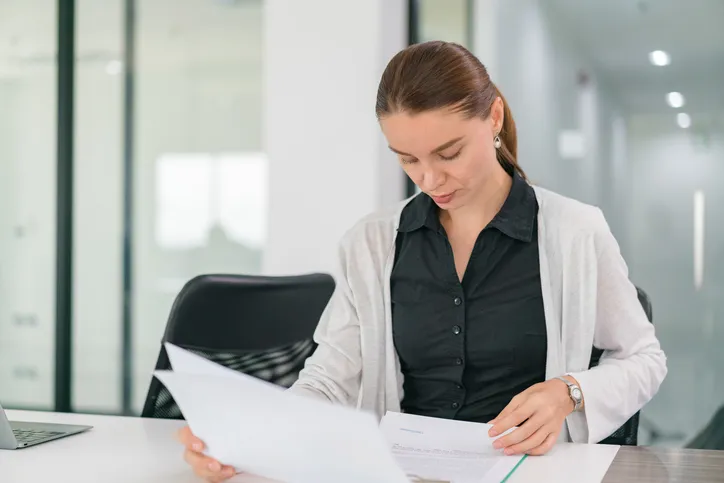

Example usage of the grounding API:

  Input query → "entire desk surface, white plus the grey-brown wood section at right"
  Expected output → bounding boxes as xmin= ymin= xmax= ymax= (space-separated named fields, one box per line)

xmin=0 ymin=411 xmax=724 ymax=483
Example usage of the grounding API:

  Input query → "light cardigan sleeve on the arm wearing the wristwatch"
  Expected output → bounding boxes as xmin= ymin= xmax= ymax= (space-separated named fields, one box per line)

xmin=569 ymin=210 xmax=667 ymax=443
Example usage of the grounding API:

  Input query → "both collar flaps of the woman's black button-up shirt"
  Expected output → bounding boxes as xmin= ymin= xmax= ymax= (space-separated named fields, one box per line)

xmin=397 ymin=172 xmax=538 ymax=242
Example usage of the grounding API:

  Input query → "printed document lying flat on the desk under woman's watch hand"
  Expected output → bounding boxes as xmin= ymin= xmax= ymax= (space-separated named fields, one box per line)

xmin=380 ymin=412 xmax=524 ymax=483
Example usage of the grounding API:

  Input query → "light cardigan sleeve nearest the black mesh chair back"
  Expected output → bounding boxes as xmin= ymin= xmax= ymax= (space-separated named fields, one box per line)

xmin=289 ymin=234 xmax=362 ymax=405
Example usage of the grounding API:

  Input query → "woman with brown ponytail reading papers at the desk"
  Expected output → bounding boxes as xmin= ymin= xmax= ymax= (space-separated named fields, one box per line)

xmin=181 ymin=42 xmax=666 ymax=478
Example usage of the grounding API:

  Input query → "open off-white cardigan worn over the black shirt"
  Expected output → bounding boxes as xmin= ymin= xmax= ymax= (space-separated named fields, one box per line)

xmin=290 ymin=187 xmax=666 ymax=443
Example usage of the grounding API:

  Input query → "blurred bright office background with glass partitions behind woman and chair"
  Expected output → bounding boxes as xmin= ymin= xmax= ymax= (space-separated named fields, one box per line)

xmin=0 ymin=0 xmax=724 ymax=445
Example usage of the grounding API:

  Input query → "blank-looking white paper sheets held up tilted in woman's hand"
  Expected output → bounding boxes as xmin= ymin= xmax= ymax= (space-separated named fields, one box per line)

xmin=155 ymin=346 xmax=408 ymax=483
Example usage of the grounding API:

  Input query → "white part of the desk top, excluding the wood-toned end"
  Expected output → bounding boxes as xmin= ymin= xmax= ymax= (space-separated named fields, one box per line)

xmin=0 ymin=411 xmax=624 ymax=483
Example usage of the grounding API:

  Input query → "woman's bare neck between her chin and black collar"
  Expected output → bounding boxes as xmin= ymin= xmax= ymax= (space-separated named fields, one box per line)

xmin=440 ymin=167 xmax=513 ymax=236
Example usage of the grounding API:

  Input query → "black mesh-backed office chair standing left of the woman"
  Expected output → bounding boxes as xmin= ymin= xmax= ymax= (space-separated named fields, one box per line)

xmin=141 ymin=274 xmax=335 ymax=419
